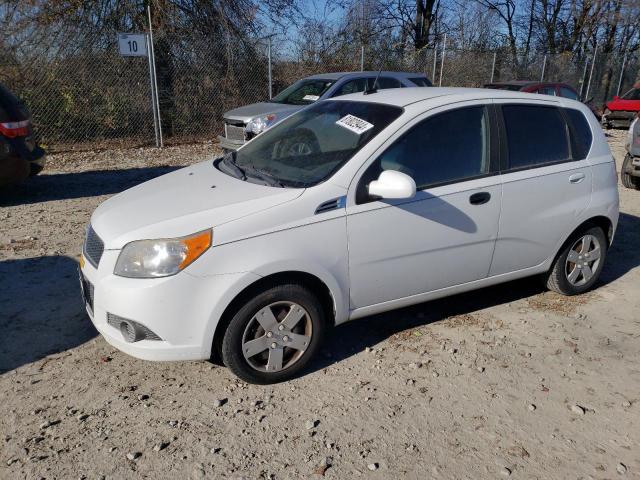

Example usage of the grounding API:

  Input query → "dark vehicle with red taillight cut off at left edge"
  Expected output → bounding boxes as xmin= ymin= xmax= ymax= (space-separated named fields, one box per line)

xmin=0 ymin=83 xmax=46 ymax=185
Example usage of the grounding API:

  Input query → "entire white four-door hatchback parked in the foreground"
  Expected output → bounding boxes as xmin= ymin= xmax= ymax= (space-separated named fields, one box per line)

xmin=81 ymin=88 xmax=618 ymax=383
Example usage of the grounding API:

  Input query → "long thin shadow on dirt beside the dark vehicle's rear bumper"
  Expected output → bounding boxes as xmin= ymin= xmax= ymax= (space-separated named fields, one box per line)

xmin=0 ymin=166 xmax=180 ymax=206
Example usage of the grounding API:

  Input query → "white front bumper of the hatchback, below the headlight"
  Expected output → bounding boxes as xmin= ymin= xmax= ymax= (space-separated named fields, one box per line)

xmin=81 ymin=250 xmax=259 ymax=360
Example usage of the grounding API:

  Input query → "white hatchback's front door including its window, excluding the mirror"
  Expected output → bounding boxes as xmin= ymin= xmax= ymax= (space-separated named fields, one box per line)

xmin=347 ymin=104 xmax=501 ymax=309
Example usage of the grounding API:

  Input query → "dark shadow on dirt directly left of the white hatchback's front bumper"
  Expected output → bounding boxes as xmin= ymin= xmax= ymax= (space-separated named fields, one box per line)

xmin=0 ymin=256 xmax=97 ymax=373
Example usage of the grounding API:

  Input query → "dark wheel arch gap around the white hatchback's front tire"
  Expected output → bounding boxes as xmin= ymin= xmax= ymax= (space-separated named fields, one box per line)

xmin=211 ymin=271 xmax=337 ymax=364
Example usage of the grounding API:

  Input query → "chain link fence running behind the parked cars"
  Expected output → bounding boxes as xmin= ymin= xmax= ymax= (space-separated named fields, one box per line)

xmin=0 ymin=32 xmax=640 ymax=151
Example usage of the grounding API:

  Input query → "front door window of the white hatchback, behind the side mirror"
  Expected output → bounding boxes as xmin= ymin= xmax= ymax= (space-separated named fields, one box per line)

xmin=357 ymin=106 xmax=489 ymax=203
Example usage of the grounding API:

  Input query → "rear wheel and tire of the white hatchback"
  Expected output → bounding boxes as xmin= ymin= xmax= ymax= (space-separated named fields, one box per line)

xmin=545 ymin=227 xmax=607 ymax=295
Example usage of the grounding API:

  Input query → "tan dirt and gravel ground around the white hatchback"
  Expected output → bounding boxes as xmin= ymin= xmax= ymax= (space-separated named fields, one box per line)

xmin=0 ymin=132 xmax=640 ymax=479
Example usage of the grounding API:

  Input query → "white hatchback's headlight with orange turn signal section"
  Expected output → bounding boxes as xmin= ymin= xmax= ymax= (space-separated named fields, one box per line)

xmin=113 ymin=230 xmax=213 ymax=278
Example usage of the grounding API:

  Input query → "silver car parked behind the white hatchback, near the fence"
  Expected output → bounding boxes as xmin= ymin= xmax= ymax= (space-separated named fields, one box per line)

xmin=218 ymin=71 xmax=432 ymax=150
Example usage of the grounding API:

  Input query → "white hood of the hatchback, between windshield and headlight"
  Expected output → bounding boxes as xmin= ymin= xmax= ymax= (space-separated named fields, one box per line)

xmin=91 ymin=160 xmax=304 ymax=250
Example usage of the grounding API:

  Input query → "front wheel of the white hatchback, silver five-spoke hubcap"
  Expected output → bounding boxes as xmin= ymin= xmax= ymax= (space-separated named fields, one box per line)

xmin=222 ymin=284 xmax=326 ymax=385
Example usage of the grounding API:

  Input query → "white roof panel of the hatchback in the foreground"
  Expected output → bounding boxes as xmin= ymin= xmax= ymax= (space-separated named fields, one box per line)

xmin=329 ymin=87 xmax=566 ymax=107
